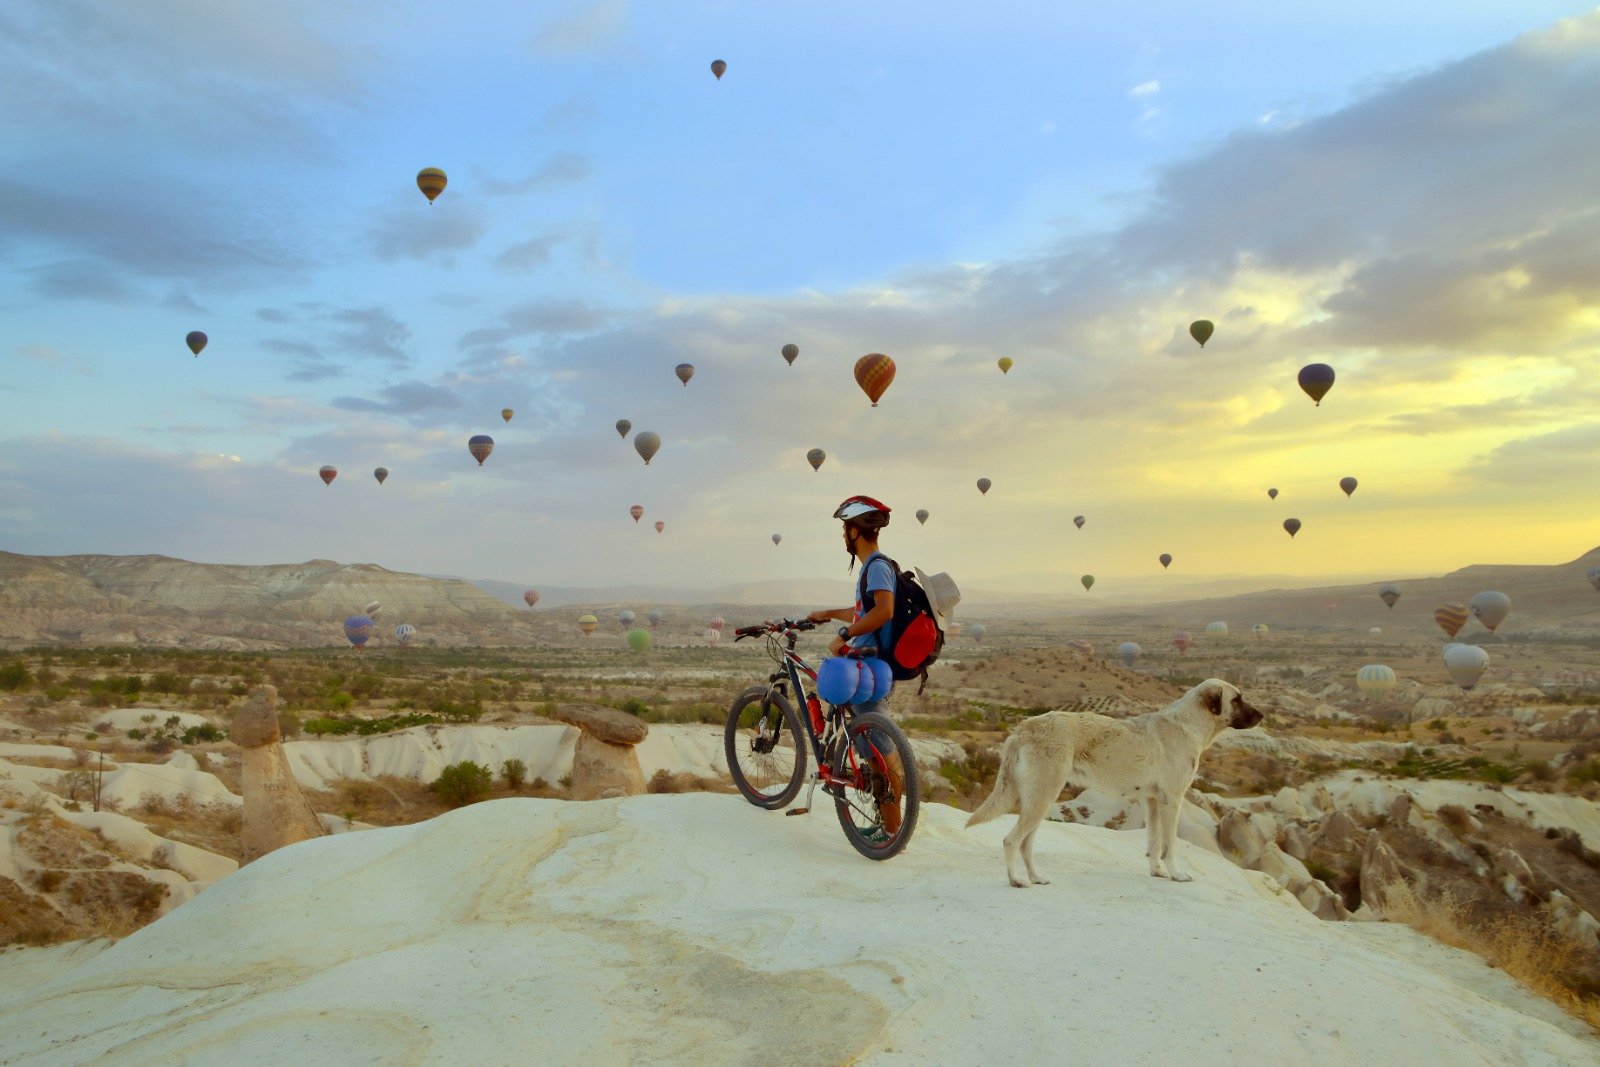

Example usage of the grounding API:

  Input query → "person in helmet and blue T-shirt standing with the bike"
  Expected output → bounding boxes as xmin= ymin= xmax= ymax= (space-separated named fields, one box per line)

xmin=808 ymin=496 xmax=906 ymax=837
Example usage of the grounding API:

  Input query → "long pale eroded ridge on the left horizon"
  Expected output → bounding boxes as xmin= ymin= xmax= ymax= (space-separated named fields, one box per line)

xmin=0 ymin=552 xmax=520 ymax=648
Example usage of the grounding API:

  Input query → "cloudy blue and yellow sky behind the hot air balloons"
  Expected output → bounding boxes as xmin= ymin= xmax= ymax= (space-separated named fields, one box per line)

xmin=0 ymin=0 xmax=1600 ymax=593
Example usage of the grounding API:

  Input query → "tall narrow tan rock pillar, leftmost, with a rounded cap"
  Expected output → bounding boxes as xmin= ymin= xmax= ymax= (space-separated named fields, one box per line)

xmin=232 ymin=685 xmax=326 ymax=864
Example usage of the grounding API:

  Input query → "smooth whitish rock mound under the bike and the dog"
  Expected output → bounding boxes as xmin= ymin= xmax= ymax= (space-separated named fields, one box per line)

xmin=0 ymin=793 xmax=1600 ymax=1067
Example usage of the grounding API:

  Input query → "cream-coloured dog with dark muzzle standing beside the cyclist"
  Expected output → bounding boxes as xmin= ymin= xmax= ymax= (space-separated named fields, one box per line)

xmin=966 ymin=678 xmax=1261 ymax=889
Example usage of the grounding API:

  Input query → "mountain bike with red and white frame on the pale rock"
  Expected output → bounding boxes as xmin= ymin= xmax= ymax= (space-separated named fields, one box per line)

xmin=723 ymin=619 xmax=922 ymax=859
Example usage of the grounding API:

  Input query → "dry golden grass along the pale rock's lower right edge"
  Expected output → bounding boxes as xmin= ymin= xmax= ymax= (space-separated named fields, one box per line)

xmin=1382 ymin=883 xmax=1600 ymax=1033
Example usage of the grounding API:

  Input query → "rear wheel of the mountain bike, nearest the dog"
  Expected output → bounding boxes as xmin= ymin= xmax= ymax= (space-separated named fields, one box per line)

xmin=834 ymin=712 xmax=922 ymax=859
